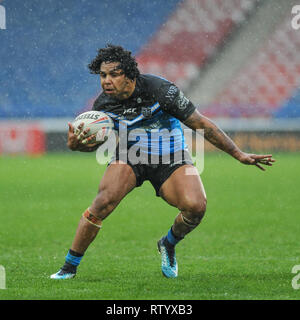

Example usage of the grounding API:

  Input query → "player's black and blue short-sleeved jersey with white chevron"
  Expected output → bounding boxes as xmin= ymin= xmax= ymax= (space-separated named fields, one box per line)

xmin=93 ymin=74 xmax=195 ymax=155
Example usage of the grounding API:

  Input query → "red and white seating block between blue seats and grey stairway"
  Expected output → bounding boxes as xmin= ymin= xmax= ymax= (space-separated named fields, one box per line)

xmin=137 ymin=0 xmax=258 ymax=89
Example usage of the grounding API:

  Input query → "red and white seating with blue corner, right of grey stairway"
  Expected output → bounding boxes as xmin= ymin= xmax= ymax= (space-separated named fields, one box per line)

xmin=202 ymin=13 xmax=300 ymax=118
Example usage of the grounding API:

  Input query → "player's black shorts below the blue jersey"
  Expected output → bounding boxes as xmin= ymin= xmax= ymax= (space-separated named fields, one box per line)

xmin=110 ymin=150 xmax=193 ymax=197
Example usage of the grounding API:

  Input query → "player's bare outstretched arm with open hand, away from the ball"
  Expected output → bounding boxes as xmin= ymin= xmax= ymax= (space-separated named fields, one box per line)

xmin=183 ymin=109 xmax=275 ymax=170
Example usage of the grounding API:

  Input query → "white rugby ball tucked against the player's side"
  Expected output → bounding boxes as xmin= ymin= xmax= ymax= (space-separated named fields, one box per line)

xmin=73 ymin=111 xmax=114 ymax=142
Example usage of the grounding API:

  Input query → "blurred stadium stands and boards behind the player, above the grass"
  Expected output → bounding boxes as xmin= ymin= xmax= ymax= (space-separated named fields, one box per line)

xmin=0 ymin=0 xmax=300 ymax=154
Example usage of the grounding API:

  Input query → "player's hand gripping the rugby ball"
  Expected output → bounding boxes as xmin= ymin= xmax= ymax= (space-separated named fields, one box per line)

xmin=67 ymin=123 xmax=99 ymax=152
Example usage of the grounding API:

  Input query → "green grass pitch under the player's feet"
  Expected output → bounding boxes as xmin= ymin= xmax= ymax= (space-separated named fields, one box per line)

xmin=0 ymin=153 xmax=300 ymax=300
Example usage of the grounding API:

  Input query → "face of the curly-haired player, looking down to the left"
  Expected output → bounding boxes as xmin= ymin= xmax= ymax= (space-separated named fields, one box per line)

xmin=100 ymin=62 xmax=132 ymax=99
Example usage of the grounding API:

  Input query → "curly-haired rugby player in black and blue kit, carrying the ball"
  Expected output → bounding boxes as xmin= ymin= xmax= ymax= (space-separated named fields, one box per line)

xmin=51 ymin=45 xmax=275 ymax=279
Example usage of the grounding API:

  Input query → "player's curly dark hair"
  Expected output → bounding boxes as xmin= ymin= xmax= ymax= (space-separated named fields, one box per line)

xmin=88 ymin=44 xmax=140 ymax=80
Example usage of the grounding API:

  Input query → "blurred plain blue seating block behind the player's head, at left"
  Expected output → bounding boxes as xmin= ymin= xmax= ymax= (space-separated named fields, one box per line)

xmin=0 ymin=0 xmax=180 ymax=119
